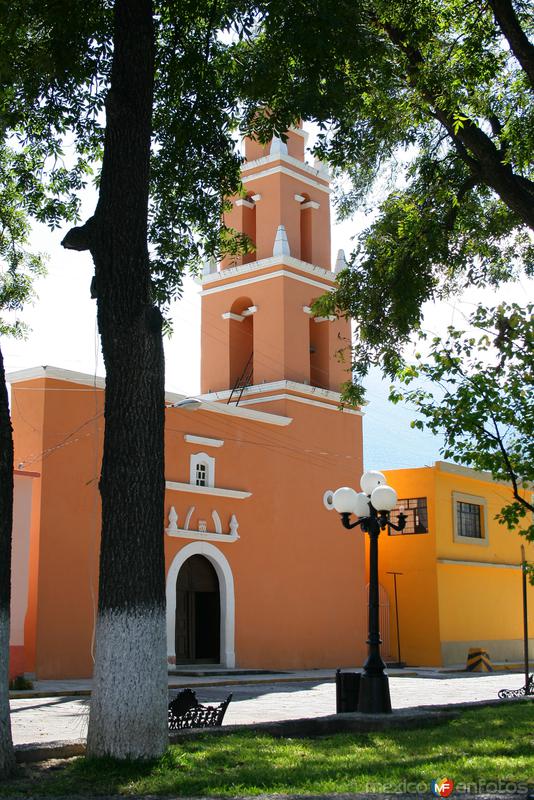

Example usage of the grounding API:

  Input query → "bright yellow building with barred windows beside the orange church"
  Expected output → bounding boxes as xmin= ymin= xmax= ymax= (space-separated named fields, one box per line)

xmin=379 ymin=461 xmax=534 ymax=666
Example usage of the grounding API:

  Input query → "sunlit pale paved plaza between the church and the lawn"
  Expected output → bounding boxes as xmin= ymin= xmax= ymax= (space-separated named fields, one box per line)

xmin=11 ymin=670 xmax=523 ymax=744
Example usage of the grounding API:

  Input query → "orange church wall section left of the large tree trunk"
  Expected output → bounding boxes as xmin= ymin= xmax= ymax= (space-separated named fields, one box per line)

xmin=12 ymin=379 xmax=103 ymax=678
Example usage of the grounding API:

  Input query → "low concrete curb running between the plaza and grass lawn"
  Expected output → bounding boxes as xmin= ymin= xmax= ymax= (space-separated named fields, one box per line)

xmin=15 ymin=697 xmax=534 ymax=764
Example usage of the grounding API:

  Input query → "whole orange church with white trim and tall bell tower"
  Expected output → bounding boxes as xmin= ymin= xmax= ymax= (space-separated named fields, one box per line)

xmin=10 ymin=130 xmax=366 ymax=679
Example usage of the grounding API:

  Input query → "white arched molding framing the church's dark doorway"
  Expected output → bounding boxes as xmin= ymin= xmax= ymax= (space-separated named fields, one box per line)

xmin=166 ymin=540 xmax=235 ymax=669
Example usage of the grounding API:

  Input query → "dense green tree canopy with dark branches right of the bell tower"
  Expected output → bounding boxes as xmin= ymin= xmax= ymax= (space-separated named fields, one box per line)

xmin=243 ymin=0 xmax=534 ymax=401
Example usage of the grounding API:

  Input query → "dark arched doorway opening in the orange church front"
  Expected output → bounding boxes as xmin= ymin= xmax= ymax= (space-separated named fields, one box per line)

xmin=175 ymin=555 xmax=221 ymax=664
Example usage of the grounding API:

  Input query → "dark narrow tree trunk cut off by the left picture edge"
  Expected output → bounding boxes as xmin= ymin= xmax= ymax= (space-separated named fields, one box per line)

xmin=0 ymin=349 xmax=15 ymax=778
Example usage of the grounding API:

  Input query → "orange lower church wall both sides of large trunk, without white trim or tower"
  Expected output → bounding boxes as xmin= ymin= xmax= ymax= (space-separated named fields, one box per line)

xmin=12 ymin=379 xmax=365 ymax=679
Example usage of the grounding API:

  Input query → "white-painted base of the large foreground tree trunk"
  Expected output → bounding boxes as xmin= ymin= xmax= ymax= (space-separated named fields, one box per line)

xmin=87 ymin=608 xmax=169 ymax=759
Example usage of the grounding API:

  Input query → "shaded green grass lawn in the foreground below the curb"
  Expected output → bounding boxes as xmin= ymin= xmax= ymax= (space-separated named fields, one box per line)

xmin=0 ymin=702 xmax=534 ymax=797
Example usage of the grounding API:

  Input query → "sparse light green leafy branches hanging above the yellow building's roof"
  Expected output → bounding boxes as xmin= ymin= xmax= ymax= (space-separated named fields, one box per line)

xmin=390 ymin=303 xmax=534 ymax=568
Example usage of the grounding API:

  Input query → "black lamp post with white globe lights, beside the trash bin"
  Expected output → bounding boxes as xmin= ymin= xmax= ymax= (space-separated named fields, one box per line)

xmin=332 ymin=471 xmax=406 ymax=714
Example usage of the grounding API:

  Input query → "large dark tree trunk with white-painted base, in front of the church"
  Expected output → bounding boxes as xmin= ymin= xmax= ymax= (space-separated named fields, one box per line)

xmin=68 ymin=0 xmax=168 ymax=758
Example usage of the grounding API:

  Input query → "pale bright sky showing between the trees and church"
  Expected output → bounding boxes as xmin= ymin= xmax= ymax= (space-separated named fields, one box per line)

xmin=2 ymin=134 xmax=534 ymax=476
